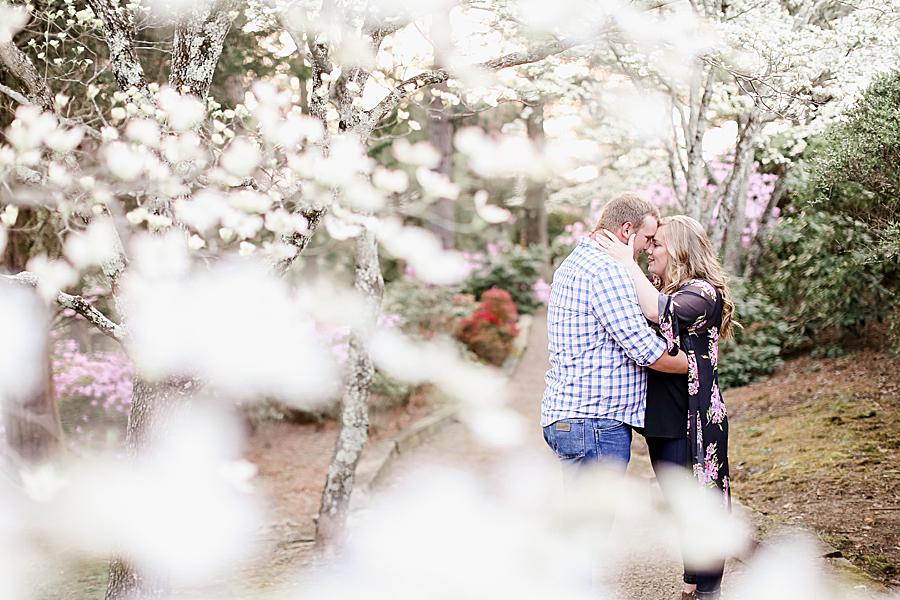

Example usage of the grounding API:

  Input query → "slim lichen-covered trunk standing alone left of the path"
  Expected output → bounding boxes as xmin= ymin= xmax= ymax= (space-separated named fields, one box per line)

xmin=316 ymin=231 xmax=384 ymax=547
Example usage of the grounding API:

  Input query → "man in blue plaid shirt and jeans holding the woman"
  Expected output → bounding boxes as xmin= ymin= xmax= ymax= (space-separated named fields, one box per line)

xmin=541 ymin=194 xmax=687 ymax=471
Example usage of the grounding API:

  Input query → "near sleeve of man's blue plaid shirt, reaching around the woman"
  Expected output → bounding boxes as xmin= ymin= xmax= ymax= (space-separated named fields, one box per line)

xmin=591 ymin=265 xmax=666 ymax=367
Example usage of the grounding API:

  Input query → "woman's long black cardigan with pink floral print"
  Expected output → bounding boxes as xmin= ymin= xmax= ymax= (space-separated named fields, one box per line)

xmin=659 ymin=279 xmax=731 ymax=506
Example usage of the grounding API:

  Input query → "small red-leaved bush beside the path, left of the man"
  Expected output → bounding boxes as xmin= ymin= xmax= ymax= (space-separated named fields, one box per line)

xmin=456 ymin=288 xmax=519 ymax=366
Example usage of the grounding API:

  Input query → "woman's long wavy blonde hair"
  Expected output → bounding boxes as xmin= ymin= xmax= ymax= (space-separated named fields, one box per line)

xmin=659 ymin=215 xmax=736 ymax=339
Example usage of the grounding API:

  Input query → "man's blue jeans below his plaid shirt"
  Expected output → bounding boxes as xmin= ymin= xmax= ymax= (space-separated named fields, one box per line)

xmin=544 ymin=419 xmax=631 ymax=473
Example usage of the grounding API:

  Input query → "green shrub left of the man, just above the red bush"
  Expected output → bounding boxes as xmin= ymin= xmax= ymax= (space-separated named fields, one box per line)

xmin=463 ymin=246 xmax=546 ymax=315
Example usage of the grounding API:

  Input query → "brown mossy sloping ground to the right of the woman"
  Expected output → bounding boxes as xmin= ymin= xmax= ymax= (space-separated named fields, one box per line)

xmin=725 ymin=352 xmax=900 ymax=586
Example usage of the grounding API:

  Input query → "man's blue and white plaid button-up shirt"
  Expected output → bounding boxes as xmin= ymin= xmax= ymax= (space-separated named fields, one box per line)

xmin=541 ymin=238 xmax=666 ymax=427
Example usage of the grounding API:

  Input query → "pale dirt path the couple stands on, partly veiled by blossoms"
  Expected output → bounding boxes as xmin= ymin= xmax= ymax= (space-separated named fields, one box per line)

xmin=383 ymin=312 xmax=740 ymax=600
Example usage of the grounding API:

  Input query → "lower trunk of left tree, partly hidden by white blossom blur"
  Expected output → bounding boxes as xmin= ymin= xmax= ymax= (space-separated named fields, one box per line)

xmin=106 ymin=377 xmax=200 ymax=600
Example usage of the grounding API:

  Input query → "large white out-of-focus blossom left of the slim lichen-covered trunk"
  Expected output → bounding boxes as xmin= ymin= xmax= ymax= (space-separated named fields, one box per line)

xmin=123 ymin=245 xmax=338 ymax=406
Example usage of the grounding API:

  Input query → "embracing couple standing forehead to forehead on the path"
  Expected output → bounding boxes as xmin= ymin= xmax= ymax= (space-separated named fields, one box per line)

xmin=541 ymin=194 xmax=734 ymax=599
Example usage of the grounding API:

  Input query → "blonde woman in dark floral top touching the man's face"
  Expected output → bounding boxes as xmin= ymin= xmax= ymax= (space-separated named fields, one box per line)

xmin=594 ymin=215 xmax=734 ymax=599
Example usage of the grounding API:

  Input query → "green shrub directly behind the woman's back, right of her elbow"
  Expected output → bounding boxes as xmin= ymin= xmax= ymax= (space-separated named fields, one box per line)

xmin=719 ymin=280 xmax=788 ymax=388
